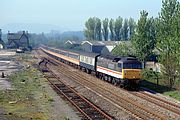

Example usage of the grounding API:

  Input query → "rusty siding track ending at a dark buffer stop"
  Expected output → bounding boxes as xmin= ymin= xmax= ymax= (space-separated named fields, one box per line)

xmin=38 ymin=60 xmax=113 ymax=120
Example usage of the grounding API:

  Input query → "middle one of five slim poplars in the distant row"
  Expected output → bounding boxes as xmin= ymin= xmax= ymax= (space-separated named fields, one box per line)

xmin=114 ymin=16 xmax=123 ymax=41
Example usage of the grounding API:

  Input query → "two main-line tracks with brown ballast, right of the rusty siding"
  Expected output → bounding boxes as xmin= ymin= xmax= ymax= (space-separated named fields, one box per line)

xmin=35 ymin=48 xmax=180 ymax=119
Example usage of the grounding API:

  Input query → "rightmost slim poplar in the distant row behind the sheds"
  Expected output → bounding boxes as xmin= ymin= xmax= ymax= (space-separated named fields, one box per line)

xmin=128 ymin=18 xmax=136 ymax=38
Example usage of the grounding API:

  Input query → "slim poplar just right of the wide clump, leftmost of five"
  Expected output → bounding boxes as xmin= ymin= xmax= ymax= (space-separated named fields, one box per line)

xmin=102 ymin=18 xmax=109 ymax=41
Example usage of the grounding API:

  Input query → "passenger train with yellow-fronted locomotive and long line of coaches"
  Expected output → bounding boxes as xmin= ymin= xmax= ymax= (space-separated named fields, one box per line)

xmin=40 ymin=45 xmax=142 ymax=89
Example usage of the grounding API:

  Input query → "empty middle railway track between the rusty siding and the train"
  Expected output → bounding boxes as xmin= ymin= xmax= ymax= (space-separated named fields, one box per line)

xmin=43 ymin=55 xmax=165 ymax=120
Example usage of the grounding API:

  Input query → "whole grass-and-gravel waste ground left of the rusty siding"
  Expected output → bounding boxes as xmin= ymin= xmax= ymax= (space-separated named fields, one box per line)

xmin=0 ymin=50 xmax=81 ymax=120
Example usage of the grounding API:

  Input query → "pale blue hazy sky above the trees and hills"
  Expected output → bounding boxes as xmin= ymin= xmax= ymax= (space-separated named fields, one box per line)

xmin=0 ymin=0 xmax=162 ymax=32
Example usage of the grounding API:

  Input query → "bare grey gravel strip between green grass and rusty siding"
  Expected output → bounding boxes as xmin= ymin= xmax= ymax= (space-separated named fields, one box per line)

xmin=35 ymin=73 xmax=80 ymax=120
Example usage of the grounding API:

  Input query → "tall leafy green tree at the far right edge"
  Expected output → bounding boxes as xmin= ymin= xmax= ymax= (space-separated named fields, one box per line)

xmin=157 ymin=0 xmax=180 ymax=88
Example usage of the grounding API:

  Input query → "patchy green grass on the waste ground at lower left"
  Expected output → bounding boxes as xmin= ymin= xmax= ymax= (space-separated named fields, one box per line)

xmin=0 ymin=68 xmax=49 ymax=120
